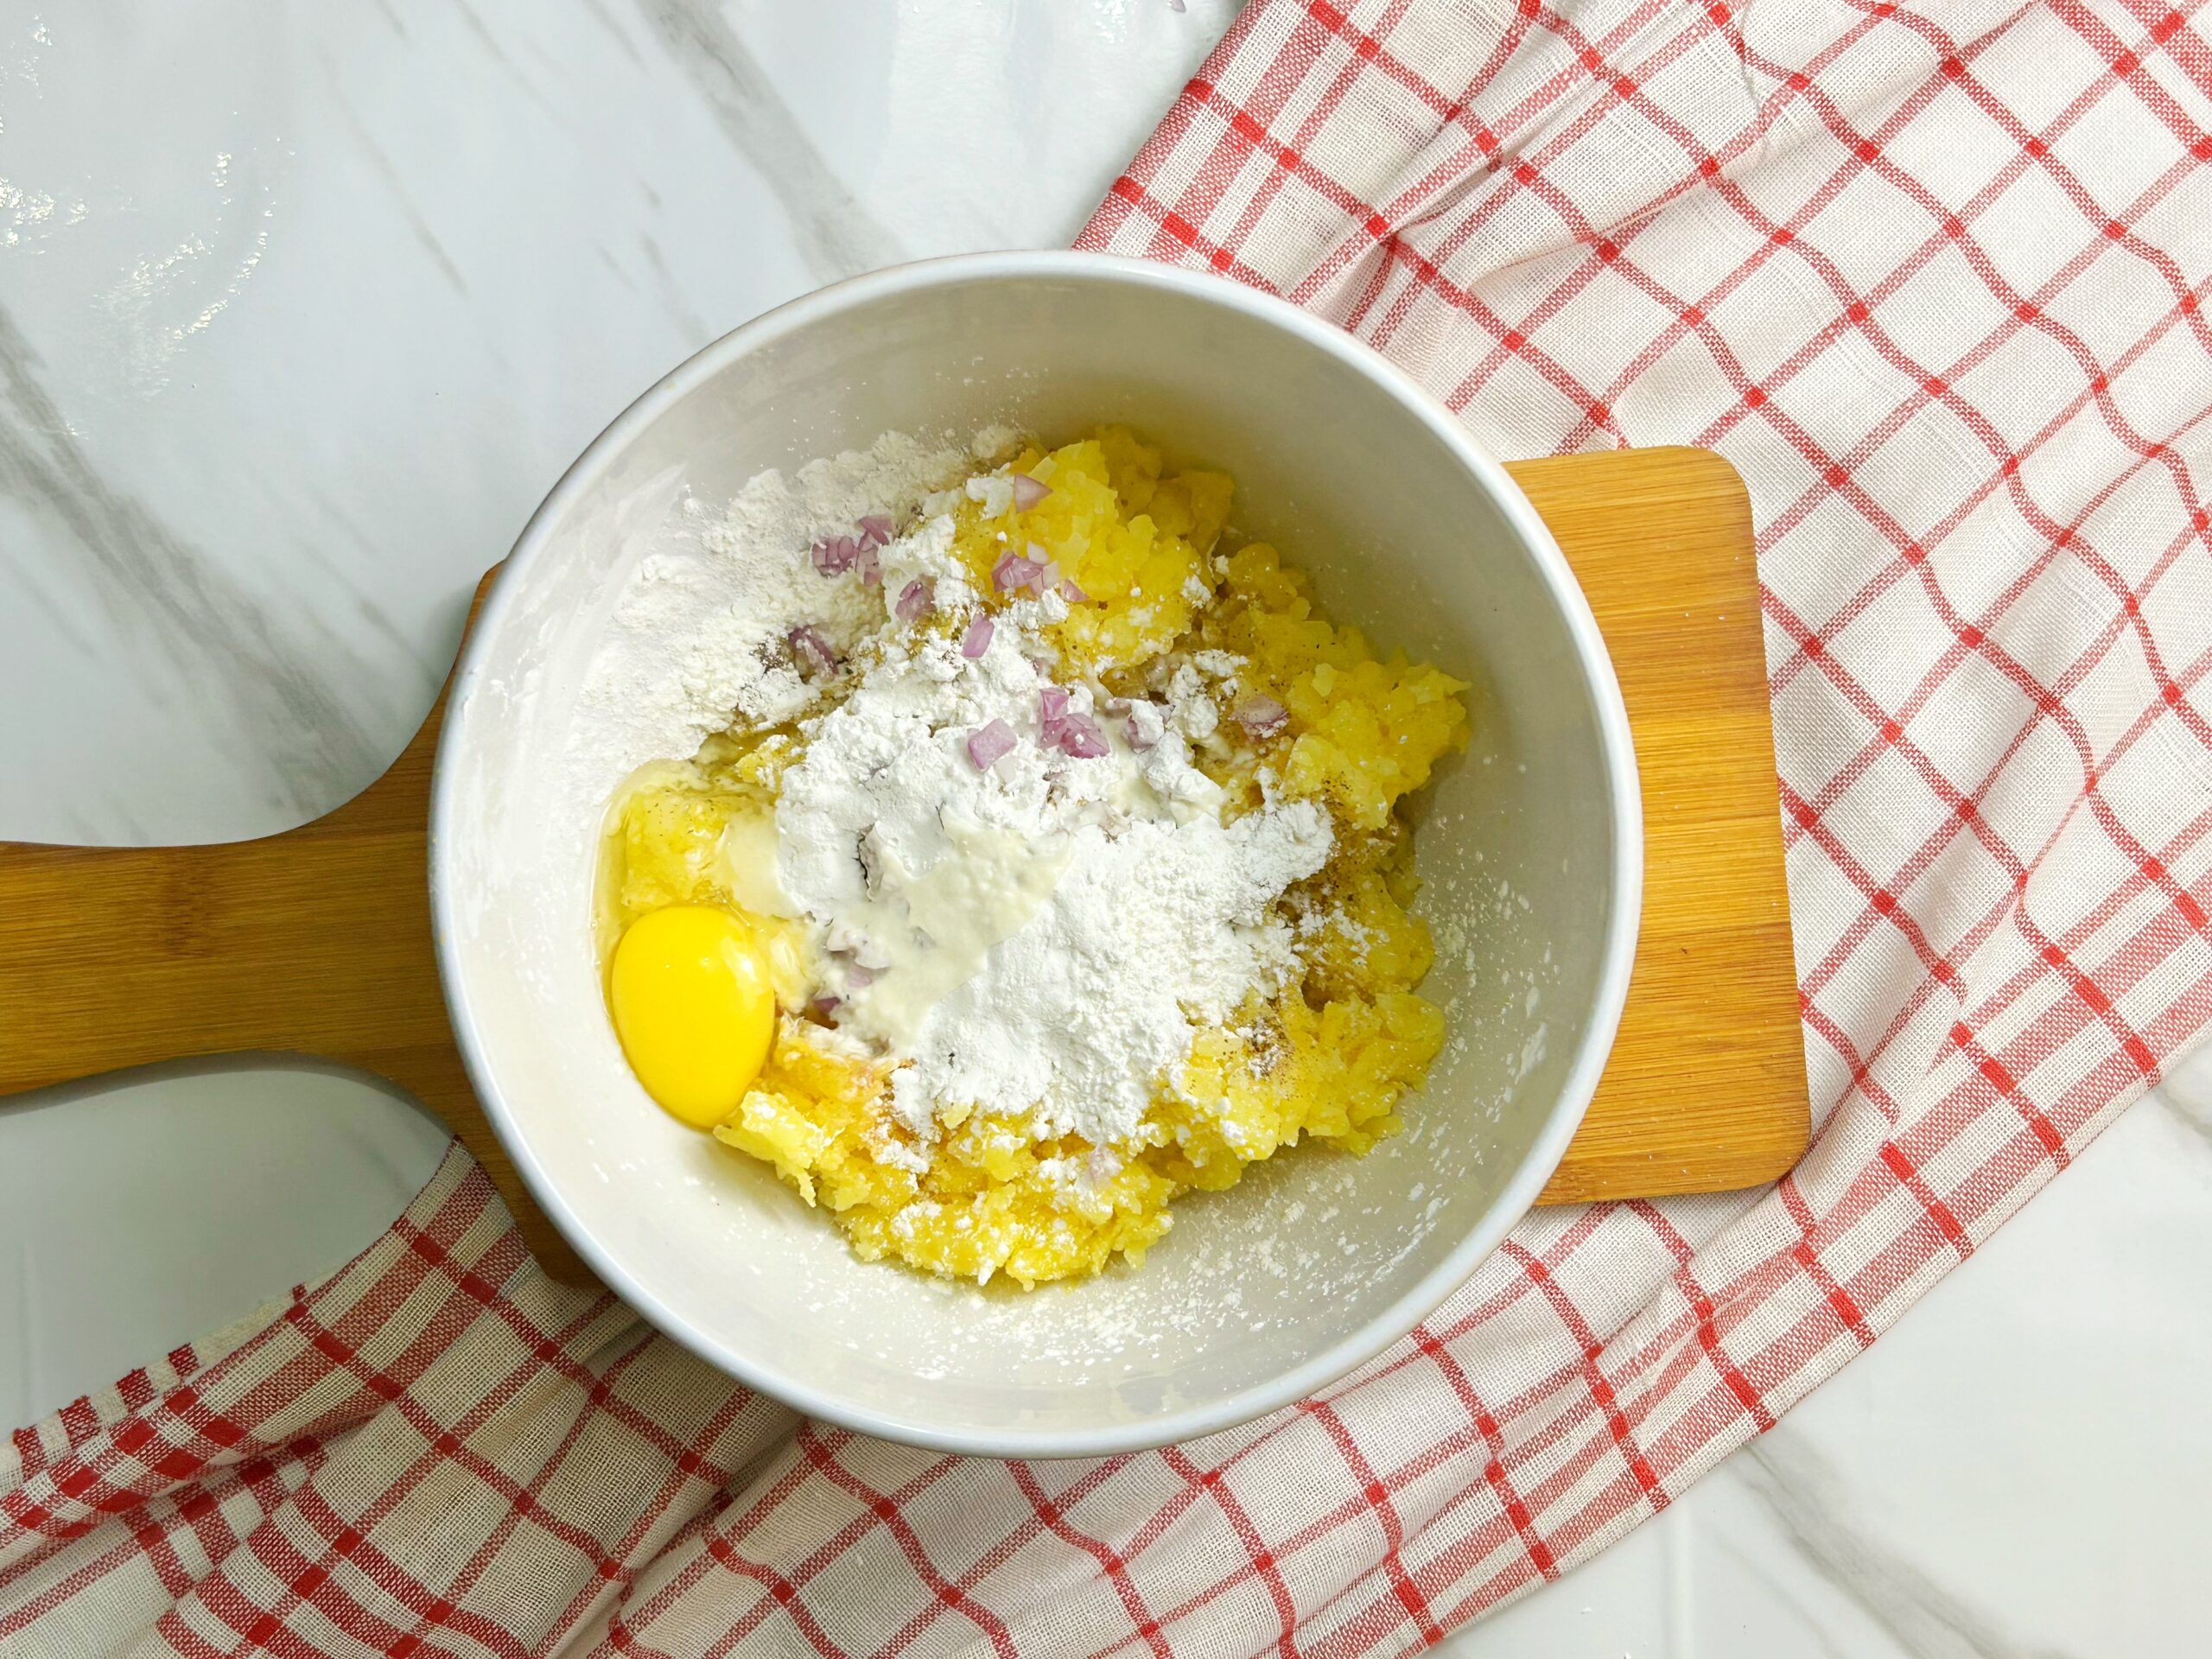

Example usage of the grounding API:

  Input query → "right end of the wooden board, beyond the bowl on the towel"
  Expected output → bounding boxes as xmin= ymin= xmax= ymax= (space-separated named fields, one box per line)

xmin=1506 ymin=449 xmax=1812 ymax=1204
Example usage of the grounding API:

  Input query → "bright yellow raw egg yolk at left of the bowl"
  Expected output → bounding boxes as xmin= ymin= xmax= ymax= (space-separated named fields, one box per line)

xmin=606 ymin=905 xmax=777 ymax=1128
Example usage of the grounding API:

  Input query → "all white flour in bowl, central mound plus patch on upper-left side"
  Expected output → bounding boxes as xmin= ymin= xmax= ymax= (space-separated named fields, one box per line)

xmin=586 ymin=434 xmax=1330 ymax=1146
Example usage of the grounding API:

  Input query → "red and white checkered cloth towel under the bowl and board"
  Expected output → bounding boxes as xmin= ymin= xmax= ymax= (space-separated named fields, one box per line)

xmin=0 ymin=0 xmax=2212 ymax=1659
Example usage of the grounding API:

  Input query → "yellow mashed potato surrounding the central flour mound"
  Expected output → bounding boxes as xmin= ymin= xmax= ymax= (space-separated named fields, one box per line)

xmin=606 ymin=427 xmax=1466 ymax=1285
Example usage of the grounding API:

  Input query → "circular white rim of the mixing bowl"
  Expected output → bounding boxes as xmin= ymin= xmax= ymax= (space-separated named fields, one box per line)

xmin=429 ymin=250 xmax=1643 ymax=1458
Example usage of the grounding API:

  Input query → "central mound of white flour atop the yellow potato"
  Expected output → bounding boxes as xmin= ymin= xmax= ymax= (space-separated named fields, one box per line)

xmin=777 ymin=601 xmax=1330 ymax=1146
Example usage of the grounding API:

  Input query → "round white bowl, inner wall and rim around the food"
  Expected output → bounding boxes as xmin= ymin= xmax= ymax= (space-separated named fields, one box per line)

xmin=431 ymin=254 xmax=1642 ymax=1458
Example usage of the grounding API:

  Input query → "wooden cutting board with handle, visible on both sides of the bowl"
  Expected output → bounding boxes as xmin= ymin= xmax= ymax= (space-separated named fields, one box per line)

xmin=0 ymin=449 xmax=1809 ymax=1281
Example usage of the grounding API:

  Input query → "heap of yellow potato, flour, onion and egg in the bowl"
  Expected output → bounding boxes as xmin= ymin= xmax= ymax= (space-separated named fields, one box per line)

xmin=600 ymin=427 xmax=1466 ymax=1285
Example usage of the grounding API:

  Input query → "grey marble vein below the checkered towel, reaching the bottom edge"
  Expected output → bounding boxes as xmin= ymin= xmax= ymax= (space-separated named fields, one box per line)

xmin=1732 ymin=1427 xmax=2069 ymax=1659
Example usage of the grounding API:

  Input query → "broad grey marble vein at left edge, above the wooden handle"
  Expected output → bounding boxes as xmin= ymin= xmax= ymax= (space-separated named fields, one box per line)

xmin=0 ymin=308 xmax=376 ymax=827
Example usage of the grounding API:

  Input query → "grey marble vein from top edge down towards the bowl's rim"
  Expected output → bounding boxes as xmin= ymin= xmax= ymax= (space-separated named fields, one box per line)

xmin=639 ymin=0 xmax=902 ymax=281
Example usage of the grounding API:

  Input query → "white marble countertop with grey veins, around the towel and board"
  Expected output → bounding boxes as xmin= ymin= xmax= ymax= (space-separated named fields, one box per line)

xmin=0 ymin=0 xmax=2212 ymax=1659
